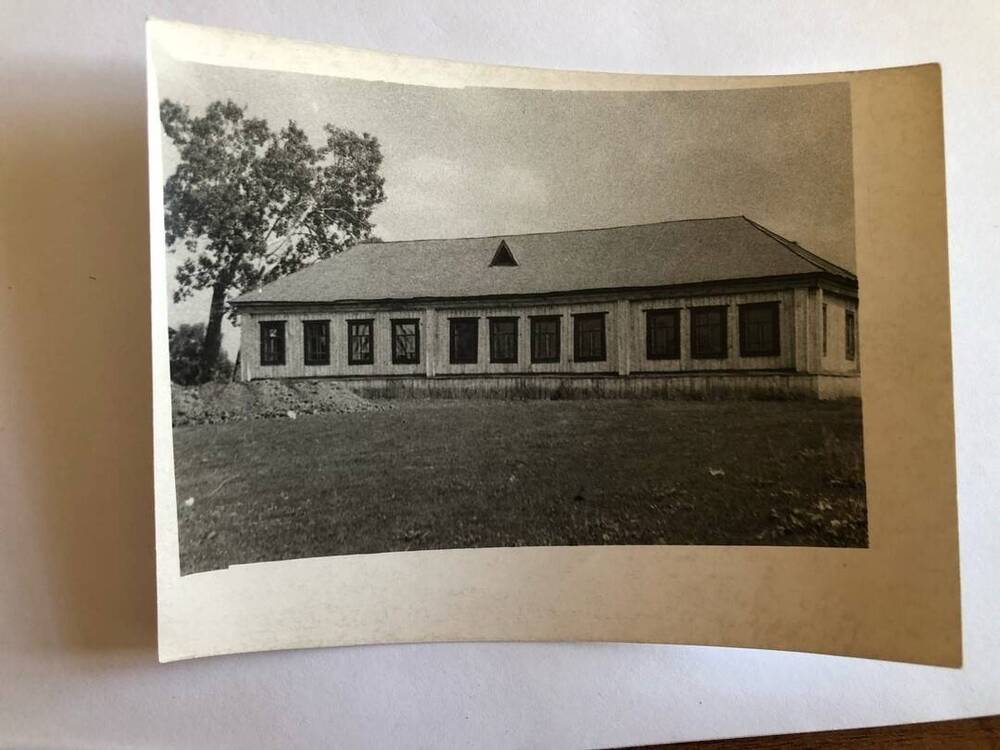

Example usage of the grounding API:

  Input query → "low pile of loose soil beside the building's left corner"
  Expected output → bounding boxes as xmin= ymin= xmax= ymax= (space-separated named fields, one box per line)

xmin=171 ymin=380 xmax=387 ymax=426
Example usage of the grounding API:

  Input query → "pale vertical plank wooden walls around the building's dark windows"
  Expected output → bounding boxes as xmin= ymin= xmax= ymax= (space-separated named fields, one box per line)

xmin=240 ymin=287 xmax=858 ymax=380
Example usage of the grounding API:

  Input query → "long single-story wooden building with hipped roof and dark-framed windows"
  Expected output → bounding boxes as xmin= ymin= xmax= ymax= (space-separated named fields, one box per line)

xmin=233 ymin=216 xmax=860 ymax=398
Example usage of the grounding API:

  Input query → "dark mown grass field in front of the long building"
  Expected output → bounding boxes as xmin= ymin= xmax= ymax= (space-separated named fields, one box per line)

xmin=174 ymin=400 xmax=867 ymax=573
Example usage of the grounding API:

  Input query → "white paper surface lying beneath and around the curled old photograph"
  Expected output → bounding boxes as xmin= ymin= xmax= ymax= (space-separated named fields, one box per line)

xmin=0 ymin=0 xmax=1000 ymax=748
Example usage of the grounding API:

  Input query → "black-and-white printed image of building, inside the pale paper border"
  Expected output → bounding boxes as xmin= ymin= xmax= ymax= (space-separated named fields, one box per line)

xmin=158 ymin=61 xmax=868 ymax=575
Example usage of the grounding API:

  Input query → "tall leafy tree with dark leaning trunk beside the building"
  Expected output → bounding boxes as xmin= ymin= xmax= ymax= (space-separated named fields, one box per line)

xmin=160 ymin=99 xmax=385 ymax=379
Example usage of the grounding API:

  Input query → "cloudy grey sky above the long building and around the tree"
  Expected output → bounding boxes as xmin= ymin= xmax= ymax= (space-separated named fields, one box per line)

xmin=158 ymin=62 xmax=855 ymax=355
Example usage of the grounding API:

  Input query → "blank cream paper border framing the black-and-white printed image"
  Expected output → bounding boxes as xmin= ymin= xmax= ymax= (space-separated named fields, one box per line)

xmin=148 ymin=16 xmax=961 ymax=666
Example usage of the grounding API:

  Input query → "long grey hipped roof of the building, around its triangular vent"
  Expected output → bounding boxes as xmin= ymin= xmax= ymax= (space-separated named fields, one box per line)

xmin=236 ymin=216 xmax=856 ymax=305
